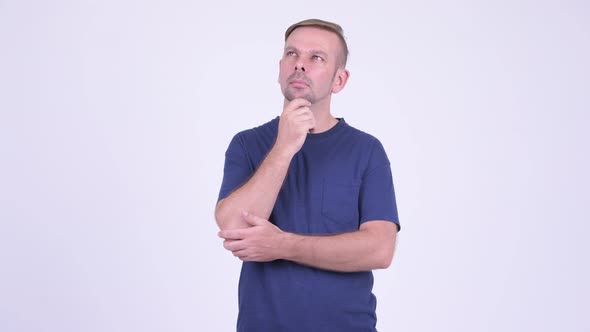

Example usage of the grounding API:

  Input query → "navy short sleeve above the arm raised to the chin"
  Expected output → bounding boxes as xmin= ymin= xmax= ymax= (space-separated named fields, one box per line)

xmin=217 ymin=134 xmax=254 ymax=201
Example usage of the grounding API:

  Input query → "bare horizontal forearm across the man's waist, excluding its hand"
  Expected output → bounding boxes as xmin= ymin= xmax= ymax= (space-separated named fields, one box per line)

xmin=280 ymin=221 xmax=396 ymax=272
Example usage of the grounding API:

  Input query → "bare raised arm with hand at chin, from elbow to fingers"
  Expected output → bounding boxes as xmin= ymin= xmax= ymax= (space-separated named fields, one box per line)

xmin=215 ymin=99 xmax=315 ymax=229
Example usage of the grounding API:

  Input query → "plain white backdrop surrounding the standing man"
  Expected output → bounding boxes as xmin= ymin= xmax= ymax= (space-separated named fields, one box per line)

xmin=0 ymin=0 xmax=590 ymax=332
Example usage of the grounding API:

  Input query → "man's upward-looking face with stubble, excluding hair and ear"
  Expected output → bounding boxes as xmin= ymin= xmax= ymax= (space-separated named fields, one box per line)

xmin=279 ymin=27 xmax=342 ymax=104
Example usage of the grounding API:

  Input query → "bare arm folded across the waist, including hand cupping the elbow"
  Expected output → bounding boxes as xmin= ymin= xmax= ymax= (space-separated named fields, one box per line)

xmin=219 ymin=213 xmax=397 ymax=272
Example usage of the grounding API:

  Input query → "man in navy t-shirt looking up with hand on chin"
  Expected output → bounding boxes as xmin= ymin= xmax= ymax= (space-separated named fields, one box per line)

xmin=215 ymin=19 xmax=399 ymax=332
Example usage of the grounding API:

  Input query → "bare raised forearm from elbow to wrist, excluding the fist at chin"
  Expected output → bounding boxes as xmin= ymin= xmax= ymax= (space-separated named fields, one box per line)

xmin=215 ymin=147 xmax=292 ymax=229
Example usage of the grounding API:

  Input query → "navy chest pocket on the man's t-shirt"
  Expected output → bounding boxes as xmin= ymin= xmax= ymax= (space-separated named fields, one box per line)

xmin=322 ymin=180 xmax=360 ymax=231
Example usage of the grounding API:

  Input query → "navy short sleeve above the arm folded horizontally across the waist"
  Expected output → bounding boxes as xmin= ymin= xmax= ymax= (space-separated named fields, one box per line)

xmin=359 ymin=140 xmax=400 ymax=230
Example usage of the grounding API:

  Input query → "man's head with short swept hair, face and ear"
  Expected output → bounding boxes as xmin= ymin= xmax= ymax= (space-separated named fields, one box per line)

xmin=279 ymin=19 xmax=349 ymax=105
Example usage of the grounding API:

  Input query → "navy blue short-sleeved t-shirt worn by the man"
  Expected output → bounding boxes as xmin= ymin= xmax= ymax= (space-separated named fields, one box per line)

xmin=219 ymin=117 xmax=399 ymax=332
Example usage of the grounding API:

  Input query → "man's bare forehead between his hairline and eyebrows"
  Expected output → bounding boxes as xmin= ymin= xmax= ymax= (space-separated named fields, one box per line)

xmin=285 ymin=27 xmax=340 ymax=53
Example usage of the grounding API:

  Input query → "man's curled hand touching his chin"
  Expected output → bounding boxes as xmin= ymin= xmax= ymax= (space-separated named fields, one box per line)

xmin=274 ymin=98 xmax=315 ymax=157
